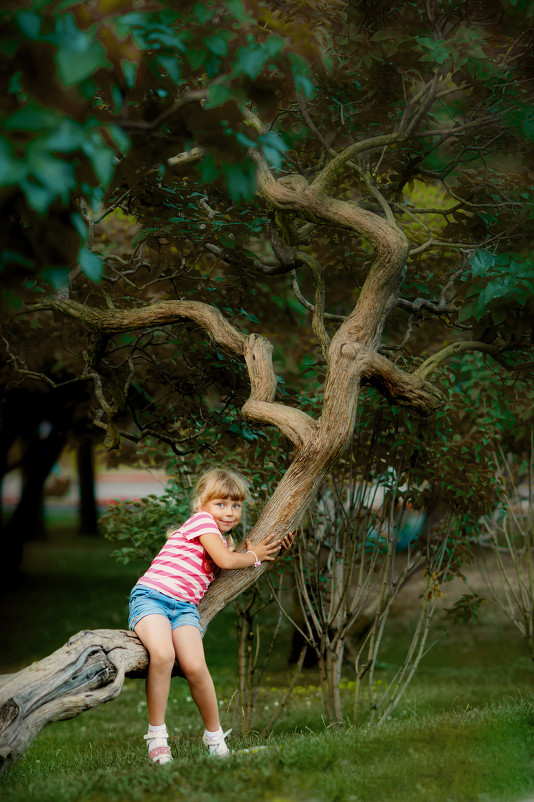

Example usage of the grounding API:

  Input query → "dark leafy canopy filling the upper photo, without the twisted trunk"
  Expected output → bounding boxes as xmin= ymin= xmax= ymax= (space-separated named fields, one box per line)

xmin=0 ymin=0 xmax=534 ymax=548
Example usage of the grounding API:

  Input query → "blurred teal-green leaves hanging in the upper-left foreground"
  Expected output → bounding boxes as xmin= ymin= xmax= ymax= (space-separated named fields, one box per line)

xmin=0 ymin=0 xmax=317 ymax=286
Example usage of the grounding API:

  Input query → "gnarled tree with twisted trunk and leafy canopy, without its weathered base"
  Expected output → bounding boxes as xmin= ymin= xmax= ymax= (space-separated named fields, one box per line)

xmin=2 ymin=0 xmax=534 ymax=764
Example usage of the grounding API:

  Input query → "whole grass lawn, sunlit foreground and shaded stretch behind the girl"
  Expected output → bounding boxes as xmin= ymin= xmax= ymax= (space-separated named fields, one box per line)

xmin=0 ymin=520 xmax=534 ymax=802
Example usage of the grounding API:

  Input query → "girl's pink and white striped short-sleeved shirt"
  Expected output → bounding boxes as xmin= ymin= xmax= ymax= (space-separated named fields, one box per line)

xmin=138 ymin=511 xmax=228 ymax=604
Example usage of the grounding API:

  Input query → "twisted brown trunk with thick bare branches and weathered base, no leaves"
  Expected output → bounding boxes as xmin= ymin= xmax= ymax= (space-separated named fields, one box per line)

xmin=5 ymin=117 xmax=439 ymax=768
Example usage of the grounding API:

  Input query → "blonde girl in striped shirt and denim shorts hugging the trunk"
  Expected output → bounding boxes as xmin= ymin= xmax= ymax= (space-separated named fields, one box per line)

xmin=129 ymin=468 xmax=291 ymax=763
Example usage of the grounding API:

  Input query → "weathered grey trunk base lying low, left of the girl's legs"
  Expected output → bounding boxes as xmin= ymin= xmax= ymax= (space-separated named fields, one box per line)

xmin=0 ymin=629 xmax=170 ymax=774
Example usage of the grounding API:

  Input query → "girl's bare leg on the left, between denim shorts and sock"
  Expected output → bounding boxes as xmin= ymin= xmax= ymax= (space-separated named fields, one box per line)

xmin=135 ymin=615 xmax=176 ymax=726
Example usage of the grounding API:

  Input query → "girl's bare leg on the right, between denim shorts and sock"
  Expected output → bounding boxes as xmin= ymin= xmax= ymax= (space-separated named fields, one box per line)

xmin=172 ymin=625 xmax=220 ymax=732
